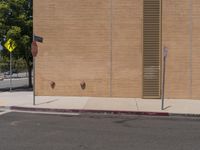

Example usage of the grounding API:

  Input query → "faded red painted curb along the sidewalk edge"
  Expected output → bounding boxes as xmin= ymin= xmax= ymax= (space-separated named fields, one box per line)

xmin=10 ymin=106 xmax=169 ymax=116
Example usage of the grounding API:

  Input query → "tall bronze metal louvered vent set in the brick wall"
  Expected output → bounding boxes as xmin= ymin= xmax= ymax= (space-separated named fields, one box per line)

xmin=143 ymin=0 xmax=161 ymax=98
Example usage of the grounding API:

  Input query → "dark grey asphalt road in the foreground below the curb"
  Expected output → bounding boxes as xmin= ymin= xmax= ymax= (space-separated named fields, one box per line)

xmin=0 ymin=112 xmax=200 ymax=150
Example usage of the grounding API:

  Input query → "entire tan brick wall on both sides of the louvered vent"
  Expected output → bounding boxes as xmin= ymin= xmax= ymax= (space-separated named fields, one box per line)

xmin=34 ymin=0 xmax=200 ymax=99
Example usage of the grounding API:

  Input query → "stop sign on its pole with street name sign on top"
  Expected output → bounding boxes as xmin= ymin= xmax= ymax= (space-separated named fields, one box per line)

xmin=31 ymin=34 xmax=43 ymax=105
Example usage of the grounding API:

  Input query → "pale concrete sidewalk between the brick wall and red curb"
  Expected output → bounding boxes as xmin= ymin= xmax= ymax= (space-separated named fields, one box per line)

xmin=0 ymin=92 xmax=200 ymax=116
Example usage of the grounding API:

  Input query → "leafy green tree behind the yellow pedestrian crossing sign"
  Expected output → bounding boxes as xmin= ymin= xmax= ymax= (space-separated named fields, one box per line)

xmin=0 ymin=0 xmax=33 ymax=87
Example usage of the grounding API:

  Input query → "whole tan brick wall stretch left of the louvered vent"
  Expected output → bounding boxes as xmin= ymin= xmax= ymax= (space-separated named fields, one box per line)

xmin=34 ymin=0 xmax=142 ymax=97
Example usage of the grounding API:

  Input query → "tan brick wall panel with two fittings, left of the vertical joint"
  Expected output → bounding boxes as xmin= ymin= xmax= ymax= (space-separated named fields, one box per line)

xmin=34 ymin=0 xmax=110 ymax=96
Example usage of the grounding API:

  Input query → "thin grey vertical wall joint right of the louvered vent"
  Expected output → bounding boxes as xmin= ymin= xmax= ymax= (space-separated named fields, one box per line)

xmin=189 ymin=0 xmax=193 ymax=98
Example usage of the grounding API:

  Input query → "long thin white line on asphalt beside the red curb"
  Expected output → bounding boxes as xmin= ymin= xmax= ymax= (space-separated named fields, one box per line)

xmin=12 ymin=110 xmax=80 ymax=116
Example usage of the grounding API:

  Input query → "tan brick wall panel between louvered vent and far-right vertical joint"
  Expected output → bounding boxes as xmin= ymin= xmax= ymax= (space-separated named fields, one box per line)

xmin=162 ymin=0 xmax=191 ymax=98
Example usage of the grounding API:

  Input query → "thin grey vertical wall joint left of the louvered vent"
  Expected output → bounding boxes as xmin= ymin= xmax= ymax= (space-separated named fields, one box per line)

xmin=110 ymin=0 xmax=113 ymax=97
